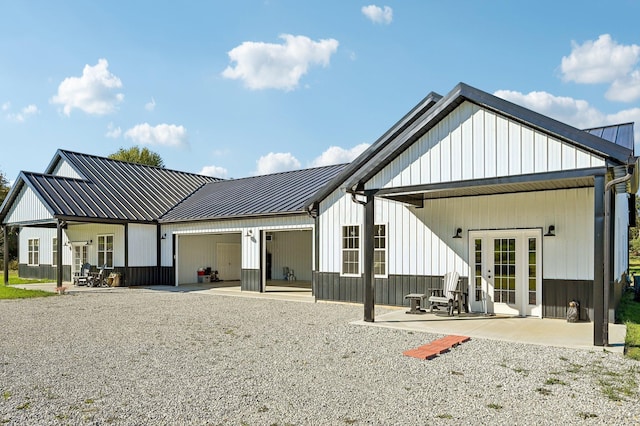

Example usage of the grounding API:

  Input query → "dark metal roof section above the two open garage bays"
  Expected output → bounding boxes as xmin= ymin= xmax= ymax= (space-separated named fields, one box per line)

xmin=160 ymin=164 xmax=347 ymax=222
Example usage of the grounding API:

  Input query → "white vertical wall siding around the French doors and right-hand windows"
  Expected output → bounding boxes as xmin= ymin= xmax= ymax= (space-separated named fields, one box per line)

xmin=319 ymin=188 xmax=594 ymax=280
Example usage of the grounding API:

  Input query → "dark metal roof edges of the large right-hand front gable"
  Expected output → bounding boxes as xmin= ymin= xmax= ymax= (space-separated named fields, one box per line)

xmin=307 ymin=83 xmax=633 ymax=210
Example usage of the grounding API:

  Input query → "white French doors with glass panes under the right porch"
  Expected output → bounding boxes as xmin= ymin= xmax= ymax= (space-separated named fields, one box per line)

xmin=469 ymin=229 xmax=542 ymax=317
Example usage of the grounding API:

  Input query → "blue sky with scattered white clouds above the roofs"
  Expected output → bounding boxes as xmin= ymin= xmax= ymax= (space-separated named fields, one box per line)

xmin=0 ymin=0 xmax=640 ymax=180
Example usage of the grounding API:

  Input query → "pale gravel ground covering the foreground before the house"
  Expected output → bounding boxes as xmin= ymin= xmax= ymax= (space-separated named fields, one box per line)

xmin=0 ymin=289 xmax=640 ymax=425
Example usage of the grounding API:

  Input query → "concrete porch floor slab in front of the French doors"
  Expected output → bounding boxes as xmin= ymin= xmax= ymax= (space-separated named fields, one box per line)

xmin=353 ymin=306 xmax=626 ymax=353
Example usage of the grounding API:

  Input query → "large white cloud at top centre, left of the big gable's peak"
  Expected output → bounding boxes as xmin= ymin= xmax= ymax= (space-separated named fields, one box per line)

xmin=222 ymin=34 xmax=338 ymax=90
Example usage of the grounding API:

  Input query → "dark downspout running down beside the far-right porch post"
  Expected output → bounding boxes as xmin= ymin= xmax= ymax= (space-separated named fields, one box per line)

xmin=602 ymin=165 xmax=633 ymax=346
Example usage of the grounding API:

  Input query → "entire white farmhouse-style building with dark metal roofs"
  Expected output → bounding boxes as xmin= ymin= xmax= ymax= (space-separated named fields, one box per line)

xmin=0 ymin=83 xmax=638 ymax=344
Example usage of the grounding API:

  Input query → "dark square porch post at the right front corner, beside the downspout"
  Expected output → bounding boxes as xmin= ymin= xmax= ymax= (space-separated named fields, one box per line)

xmin=593 ymin=175 xmax=607 ymax=346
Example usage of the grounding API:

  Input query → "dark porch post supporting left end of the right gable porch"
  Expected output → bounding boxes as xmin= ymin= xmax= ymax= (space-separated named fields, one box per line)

xmin=362 ymin=191 xmax=375 ymax=322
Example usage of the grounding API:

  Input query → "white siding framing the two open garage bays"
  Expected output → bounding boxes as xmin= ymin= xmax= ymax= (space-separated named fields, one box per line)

xmin=160 ymin=214 xmax=314 ymax=269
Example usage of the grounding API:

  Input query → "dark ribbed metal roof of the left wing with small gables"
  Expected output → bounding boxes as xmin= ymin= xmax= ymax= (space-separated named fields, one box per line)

xmin=0 ymin=150 xmax=218 ymax=222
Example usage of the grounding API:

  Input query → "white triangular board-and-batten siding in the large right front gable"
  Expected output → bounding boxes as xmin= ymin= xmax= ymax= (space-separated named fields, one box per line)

xmin=365 ymin=102 xmax=605 ymax=189
